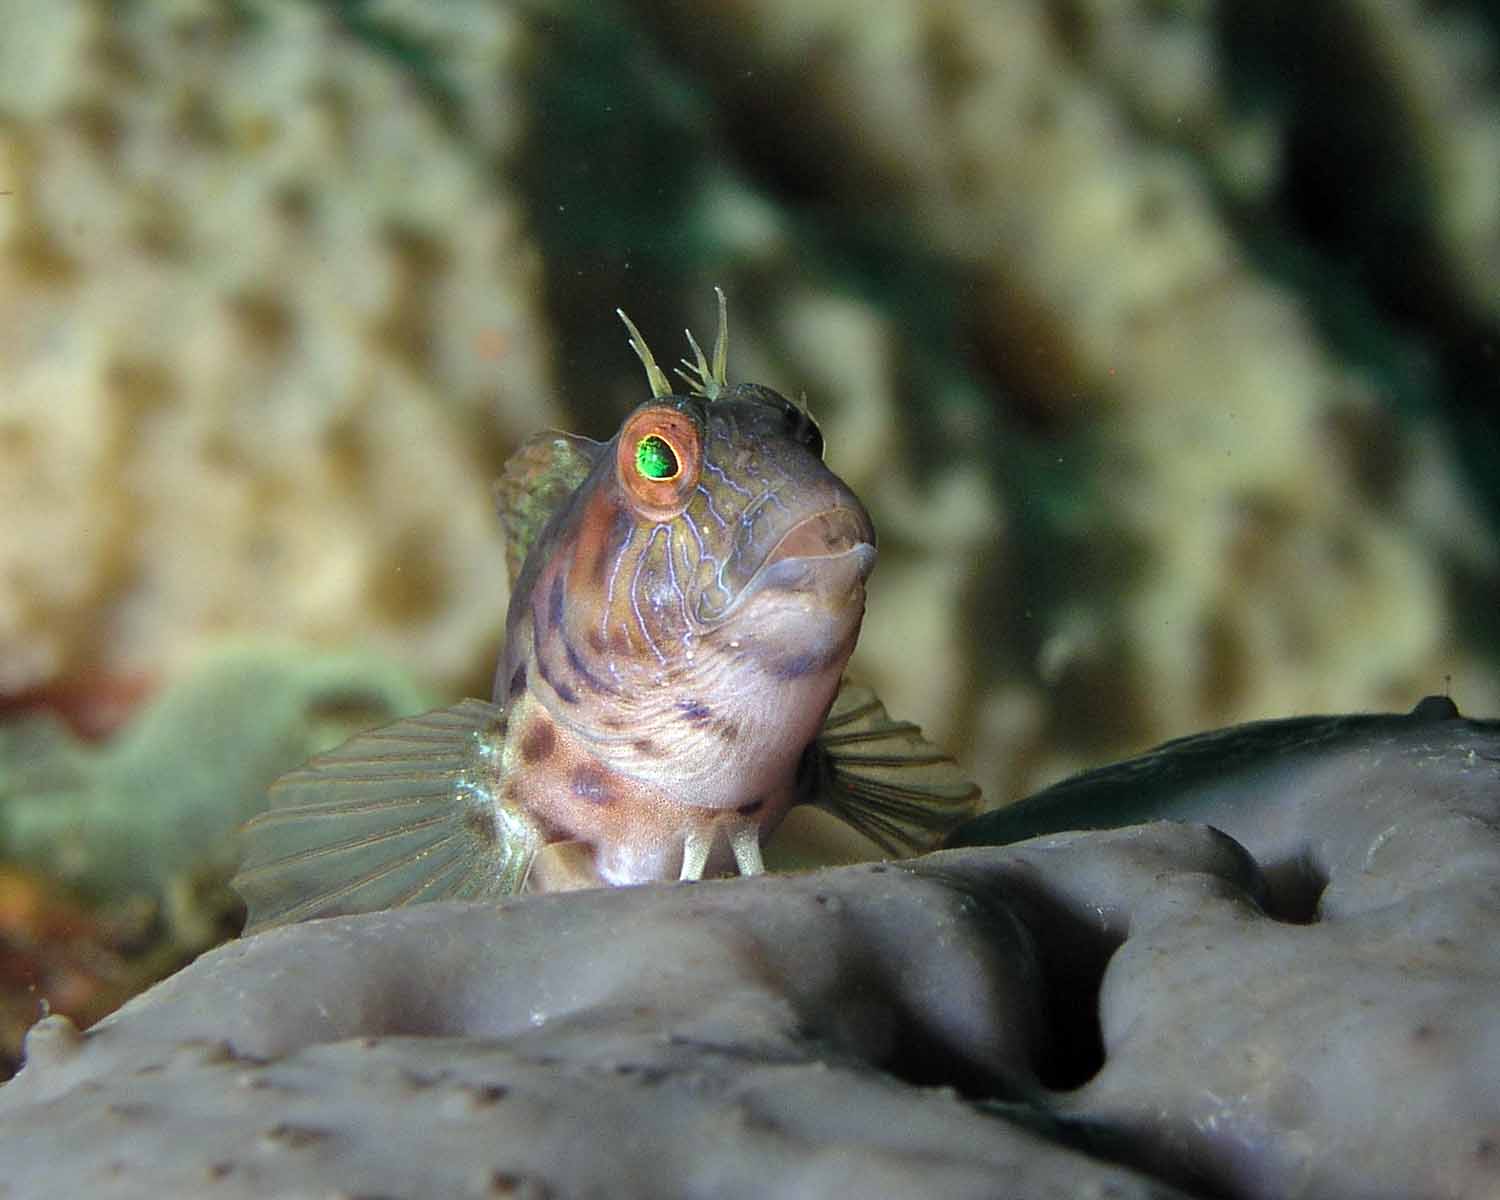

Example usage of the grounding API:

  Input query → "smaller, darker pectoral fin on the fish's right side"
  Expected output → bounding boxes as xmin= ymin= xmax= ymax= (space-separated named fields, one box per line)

xmin=804 ymin=683 xmax=980 ymax=855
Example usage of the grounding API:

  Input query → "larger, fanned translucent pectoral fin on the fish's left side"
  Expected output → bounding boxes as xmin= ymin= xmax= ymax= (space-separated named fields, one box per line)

xmin=230 ymin=701 xmax=542 ymax=933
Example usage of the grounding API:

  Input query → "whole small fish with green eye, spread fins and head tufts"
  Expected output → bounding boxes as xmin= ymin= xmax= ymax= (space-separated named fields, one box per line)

xmin=234 ymin=294 xmax=978 ymax=930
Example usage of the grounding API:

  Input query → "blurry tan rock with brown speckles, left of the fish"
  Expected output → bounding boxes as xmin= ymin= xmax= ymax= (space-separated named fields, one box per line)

xmin=0 ymin=0 xmax=552 ymax=692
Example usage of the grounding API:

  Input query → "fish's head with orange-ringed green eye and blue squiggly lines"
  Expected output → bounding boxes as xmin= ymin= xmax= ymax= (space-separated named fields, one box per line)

xmin=563 ymin=384 xmax=876 ymax=686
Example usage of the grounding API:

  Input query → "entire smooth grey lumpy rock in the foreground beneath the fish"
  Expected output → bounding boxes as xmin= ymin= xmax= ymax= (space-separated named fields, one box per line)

xmin=0 ymin=699 xmax=1500 ymax=1200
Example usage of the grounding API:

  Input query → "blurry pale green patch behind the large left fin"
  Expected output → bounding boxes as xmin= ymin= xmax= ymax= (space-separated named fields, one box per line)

xmin=0 ymin=644 xmax=435 ymax=930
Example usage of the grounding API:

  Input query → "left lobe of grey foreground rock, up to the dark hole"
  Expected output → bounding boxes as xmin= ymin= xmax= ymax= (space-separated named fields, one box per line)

xmin=0 ymin=846 xmax=1194 ymax=1197
